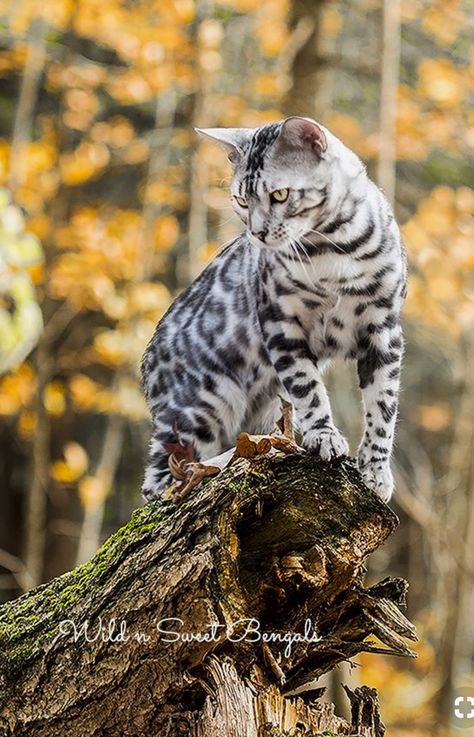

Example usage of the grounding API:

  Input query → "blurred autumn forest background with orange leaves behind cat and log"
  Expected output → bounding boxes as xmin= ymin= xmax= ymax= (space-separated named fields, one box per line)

xmin=0 ymin=0 xmax=474 ymax=737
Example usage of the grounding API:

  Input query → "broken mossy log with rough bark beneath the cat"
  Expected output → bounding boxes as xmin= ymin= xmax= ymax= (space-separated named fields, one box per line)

xmin=0 ymin=456 xmax=415 ymax=737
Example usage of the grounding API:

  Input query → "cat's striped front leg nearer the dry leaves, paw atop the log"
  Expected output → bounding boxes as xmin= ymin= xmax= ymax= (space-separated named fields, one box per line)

xmin=267 ymin=334 xmax=349 ymax=461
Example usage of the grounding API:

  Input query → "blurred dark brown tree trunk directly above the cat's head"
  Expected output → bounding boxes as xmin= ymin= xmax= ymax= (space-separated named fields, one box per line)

xmin=283 ymin=0 xmax=326 ymax=118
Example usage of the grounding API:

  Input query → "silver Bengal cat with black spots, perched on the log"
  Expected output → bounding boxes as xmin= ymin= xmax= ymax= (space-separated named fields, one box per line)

xmin=143 ymin=117 xmax=406 ymax=499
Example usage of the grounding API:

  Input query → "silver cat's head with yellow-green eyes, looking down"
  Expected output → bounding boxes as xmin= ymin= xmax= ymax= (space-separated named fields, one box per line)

xmin=196 ymin=116 xmax=365 ymax=248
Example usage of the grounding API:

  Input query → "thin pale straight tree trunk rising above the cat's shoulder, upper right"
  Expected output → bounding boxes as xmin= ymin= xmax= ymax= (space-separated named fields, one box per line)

xmin=377 ymin=0 xmax=400 ymax=205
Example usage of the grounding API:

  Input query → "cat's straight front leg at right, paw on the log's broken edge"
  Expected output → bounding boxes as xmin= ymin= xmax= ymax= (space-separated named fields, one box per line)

xmin=357 ymin=328 xmax=403 ymax=501
